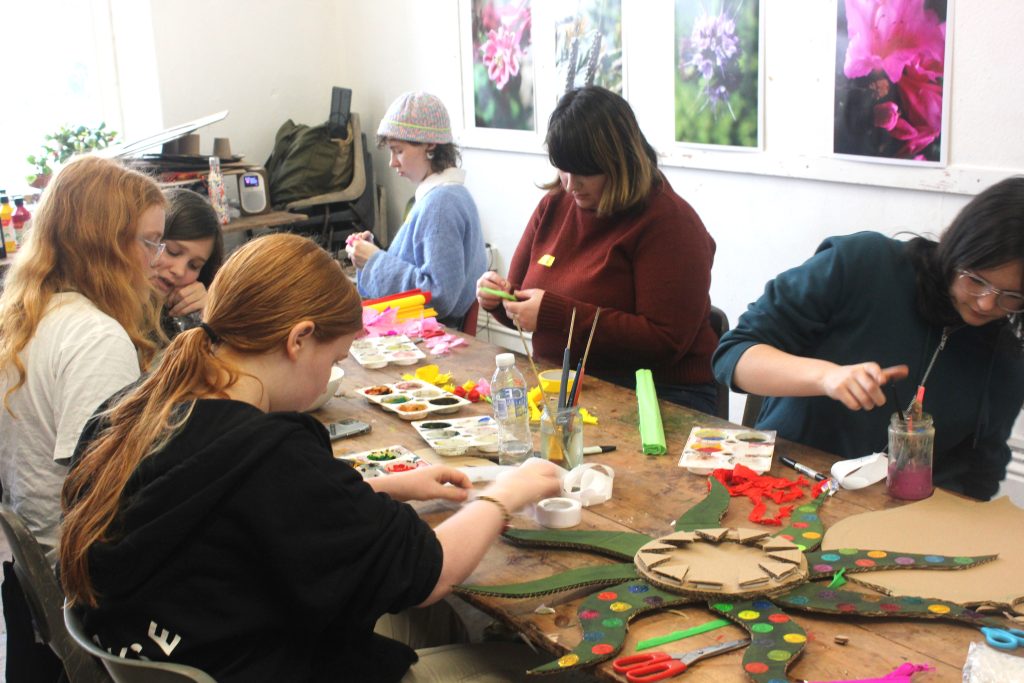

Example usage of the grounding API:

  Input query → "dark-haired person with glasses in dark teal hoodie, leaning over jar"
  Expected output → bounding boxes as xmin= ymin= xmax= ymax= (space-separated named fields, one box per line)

xmin=714 ymin=177 xmax=1024 ymax=500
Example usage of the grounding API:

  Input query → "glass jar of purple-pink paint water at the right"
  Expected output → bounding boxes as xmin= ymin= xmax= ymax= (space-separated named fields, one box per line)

xmin=886 ymin=413 xmax=935 ymax=501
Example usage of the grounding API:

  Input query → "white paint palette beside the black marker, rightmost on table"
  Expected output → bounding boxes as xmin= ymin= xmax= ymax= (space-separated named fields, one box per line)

xmin=679 ymin=426 xmax=775 ymax=474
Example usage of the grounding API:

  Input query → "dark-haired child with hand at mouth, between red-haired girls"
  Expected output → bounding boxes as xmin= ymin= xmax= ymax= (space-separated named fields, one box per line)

xmin=153 ymin=187 xmax=224 ymax=337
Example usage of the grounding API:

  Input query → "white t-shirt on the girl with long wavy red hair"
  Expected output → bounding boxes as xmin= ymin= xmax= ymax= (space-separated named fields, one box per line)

xmin=0 ymin=292 xmax=139 ymax=561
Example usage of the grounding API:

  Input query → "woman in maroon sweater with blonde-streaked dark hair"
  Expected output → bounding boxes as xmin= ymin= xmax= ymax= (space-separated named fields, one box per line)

xmin=477 ymin=87 xmax=718 ymax=413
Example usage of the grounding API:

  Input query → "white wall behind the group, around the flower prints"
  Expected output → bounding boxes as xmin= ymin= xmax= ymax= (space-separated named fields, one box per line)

xmin=152 ymin=0 xmax=1024 ymax=499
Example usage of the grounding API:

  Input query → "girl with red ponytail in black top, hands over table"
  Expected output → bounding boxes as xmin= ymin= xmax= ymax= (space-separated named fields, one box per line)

xmin=60 ymin=233 xmax=559 ymax=683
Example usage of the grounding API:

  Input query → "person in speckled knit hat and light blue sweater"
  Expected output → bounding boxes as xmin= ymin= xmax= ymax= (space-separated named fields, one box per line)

xmin=346 ymin=92 xmax=487 ymax=329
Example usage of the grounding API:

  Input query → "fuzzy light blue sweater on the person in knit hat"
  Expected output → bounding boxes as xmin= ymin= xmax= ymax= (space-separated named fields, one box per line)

xmin=357 ymin=184 xmax=487 ymax=318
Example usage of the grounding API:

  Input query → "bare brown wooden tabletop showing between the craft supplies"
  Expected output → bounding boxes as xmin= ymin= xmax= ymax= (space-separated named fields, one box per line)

xmin=316 ymin=339 xmax=981 ymax=683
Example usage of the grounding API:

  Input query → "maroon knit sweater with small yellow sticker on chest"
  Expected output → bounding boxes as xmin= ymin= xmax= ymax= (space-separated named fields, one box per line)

xmin=492 ymin=177 xmax=718 ymax=385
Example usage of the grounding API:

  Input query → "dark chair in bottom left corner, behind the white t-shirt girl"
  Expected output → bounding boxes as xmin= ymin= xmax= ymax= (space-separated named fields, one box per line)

xmin=0 ymin=505 xmax=111 ymax=683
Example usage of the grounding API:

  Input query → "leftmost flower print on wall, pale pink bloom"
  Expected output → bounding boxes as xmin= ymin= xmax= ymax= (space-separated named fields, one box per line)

xmin=472 ymin=0 xmax=535 ymax=130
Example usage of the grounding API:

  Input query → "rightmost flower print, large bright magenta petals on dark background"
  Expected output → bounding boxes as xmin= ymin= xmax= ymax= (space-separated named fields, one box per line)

xmin=833 ymin=0 xmax=948 ymax=163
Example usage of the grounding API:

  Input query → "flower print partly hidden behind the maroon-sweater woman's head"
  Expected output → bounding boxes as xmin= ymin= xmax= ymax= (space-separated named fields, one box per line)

xmin=546 ymin=0 xmax=623 ymax=100
